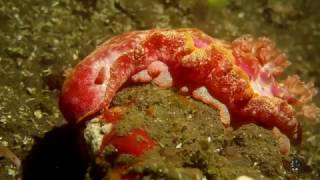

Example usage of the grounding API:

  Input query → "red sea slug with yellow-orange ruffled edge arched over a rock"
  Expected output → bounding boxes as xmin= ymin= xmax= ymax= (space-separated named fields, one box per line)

xmin=60 ymin=29 xmax=319 ymax=155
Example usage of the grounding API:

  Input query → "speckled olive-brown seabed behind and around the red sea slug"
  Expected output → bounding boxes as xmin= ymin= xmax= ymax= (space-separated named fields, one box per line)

xmin=0 ymin=0 xmax=320 ymax=180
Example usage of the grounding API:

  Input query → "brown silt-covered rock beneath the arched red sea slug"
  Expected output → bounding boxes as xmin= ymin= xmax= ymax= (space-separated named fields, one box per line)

xmin=87 ymin=85 xmax=284 ymax=179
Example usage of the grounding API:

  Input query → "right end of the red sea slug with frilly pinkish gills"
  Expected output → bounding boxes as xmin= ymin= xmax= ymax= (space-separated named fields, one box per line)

xmin=231 ymin=36 xmax=320 ymax=142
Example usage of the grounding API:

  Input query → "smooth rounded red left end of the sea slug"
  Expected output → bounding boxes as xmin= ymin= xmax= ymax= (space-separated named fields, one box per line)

xmin=59 ymin=31 xmax=145 ymax=123
